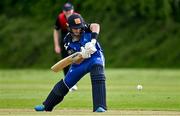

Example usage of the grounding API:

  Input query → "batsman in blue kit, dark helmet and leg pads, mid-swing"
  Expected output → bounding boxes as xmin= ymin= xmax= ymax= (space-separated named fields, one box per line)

xmin=35 ymin=14 xmax=107 ymax=112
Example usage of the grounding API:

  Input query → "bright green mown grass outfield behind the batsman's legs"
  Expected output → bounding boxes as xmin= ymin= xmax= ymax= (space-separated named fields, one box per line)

xmin=0 ymin=69 xmax=180 ymax=113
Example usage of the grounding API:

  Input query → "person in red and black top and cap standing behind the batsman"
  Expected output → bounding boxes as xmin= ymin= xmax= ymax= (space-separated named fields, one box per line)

xmin=53 ymin=2 xmax=78 ymax=91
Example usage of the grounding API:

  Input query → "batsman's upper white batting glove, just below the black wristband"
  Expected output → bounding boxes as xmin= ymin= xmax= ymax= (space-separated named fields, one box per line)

xmin=85 ymin=39 xmax=97 ymax=54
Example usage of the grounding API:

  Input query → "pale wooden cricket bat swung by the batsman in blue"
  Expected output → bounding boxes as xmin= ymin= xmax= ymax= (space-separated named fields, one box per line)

xmin=51 ymin=52 xmax=83 ymax=72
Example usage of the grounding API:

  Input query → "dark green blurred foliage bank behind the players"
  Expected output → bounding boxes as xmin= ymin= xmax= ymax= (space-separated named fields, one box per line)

xmin=0 ymin=0 xmax=180 ymax=68
